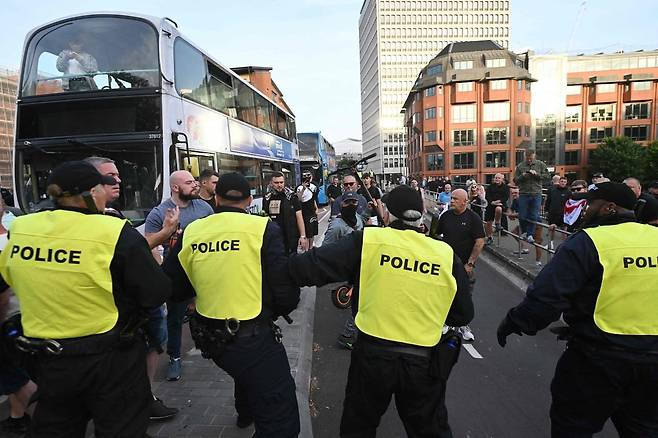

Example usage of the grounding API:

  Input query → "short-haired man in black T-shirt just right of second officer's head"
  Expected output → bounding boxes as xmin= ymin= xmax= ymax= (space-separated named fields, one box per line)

xmin=263 ymin=172 xmax=307 ymax=254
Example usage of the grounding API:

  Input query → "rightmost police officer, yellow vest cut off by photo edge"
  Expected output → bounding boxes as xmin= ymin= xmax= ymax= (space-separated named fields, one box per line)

xmin=498 ymin=182 xmax=658 ymax=437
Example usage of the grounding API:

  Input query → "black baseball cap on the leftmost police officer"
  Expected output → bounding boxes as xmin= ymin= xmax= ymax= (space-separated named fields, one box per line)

xmin=48 ymin=161 xmax=117 ymax=196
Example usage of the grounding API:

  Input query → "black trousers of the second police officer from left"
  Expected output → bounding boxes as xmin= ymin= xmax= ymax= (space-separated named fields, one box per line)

xmin=213 ymin=327 xmax=300 ymax=438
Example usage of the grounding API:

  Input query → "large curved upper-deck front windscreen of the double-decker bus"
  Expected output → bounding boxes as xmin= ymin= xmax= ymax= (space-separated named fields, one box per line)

xmin=21 ymin=17 xmax=160 ymax=97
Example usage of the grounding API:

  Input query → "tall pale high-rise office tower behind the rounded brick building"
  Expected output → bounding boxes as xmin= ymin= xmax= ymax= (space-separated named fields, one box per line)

xmin=359 ymin=0 xmax=510 ymax=180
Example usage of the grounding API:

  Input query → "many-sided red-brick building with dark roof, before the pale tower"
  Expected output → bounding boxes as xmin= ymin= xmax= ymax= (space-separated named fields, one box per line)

xmin=403 ymin=40 xmax=535 ymax=182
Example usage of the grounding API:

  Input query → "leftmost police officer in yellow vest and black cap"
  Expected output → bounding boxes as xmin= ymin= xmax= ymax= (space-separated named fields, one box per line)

xmin=0 ymin=161 xmax=171 ymax=438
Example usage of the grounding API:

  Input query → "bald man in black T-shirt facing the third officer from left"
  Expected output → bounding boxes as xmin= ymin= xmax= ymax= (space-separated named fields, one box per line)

xmin=432 ymin=189 xmax=484 ymax=341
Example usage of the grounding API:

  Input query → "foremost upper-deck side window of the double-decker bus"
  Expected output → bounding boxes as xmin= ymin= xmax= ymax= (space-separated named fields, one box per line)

xmin=174 ymin=38 xmax=210 ymax=106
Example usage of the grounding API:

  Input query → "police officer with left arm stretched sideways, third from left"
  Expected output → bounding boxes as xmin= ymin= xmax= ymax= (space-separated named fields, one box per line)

xmin=290 ymin=186 xmax=473 ymax=438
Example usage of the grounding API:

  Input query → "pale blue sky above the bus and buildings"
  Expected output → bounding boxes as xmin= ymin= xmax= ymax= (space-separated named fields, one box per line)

xmin=0 ymin=0 xmax=658 ymax=142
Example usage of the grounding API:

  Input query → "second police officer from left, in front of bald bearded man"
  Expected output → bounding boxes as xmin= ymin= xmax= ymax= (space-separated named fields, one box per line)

xmin=164 ymin=173 xmax=300 ymax=438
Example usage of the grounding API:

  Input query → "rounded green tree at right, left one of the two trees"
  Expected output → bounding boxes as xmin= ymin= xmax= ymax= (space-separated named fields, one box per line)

xmin=590 ymin=137 xmax=648 ymax=182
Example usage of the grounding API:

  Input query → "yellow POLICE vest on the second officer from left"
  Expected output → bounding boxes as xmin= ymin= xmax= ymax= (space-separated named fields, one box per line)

xmin=178 ymin=212 xmax=269 ymax=320
